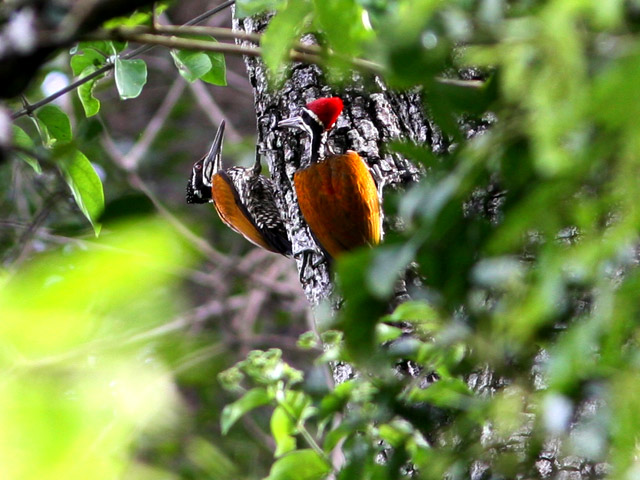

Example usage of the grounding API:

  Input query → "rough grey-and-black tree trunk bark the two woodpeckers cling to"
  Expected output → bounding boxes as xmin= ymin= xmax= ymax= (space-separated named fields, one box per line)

xmin=234 ymin=15 xmax=446 ymax=306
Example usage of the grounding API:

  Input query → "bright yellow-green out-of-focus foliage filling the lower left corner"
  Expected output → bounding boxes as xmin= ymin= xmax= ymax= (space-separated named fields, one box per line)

xmin=0 ymin=219 xmax=189 ymax=479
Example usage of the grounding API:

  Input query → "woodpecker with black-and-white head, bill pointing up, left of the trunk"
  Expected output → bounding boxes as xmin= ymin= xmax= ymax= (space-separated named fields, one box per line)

xmin=186 ymin=121 xmax=291 ymax=256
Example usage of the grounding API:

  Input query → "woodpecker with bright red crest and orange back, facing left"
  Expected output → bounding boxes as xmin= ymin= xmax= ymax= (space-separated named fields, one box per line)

xmin=278 ymin=97 xmax=382 ymax=258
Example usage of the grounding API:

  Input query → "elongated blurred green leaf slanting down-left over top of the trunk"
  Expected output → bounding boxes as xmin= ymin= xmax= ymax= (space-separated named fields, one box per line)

xmin=260 ymin=0 xmax=311 ymax=74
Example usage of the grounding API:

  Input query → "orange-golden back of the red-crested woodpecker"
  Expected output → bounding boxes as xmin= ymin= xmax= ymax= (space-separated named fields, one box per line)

xmin=293 ymin=150 xmax=382 ymax=258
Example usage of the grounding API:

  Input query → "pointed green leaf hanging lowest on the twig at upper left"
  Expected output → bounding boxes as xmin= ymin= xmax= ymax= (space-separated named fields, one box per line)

xmin=58 ymin=149 xmax=104 ymax=236
